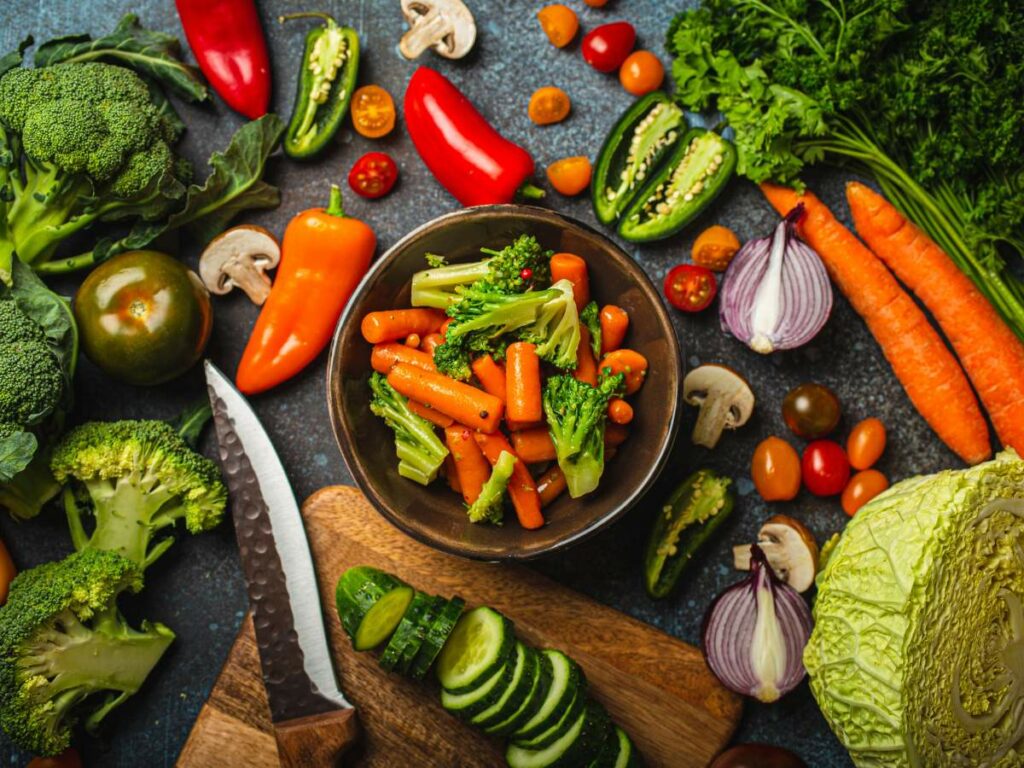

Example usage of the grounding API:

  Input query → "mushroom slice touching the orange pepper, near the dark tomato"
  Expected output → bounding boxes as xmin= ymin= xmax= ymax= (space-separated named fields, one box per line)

xmin=199 ymin=224 xmax=281 ymax=304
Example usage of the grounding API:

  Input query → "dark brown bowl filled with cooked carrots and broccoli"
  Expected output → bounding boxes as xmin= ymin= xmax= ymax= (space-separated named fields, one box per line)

xmin=328 ymin=205 xmax=681 ymax=560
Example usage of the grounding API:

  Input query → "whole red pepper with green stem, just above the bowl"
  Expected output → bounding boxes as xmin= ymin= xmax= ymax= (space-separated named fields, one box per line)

xmin=404 ymin=67 xmax=544 ymax=206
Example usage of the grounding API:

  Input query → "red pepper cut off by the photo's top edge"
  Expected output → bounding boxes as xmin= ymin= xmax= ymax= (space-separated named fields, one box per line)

xmin=175 ymin=0 xmax=270 ymax=120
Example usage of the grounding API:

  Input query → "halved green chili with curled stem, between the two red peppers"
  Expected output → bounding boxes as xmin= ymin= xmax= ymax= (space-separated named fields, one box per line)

xmin=280 ymin=13 xmax=359 ymax=159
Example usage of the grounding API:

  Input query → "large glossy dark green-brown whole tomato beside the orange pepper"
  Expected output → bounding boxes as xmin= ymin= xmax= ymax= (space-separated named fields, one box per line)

xmin=75 ymin=251 xmax=213 ymax=385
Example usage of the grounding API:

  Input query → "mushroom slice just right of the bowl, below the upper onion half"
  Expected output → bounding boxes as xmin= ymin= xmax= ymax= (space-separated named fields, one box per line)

xmin=683 ymin=365 xmax=754 ymax=449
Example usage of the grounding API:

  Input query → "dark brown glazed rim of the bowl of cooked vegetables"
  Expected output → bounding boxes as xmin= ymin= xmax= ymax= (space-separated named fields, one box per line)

xmin=326 ymin=204 xmax=682 ymax=562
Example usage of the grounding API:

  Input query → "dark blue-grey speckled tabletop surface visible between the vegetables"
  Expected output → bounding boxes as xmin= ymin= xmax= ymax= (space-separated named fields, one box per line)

xmin=0 ymin=0 xmax=974 ymax=768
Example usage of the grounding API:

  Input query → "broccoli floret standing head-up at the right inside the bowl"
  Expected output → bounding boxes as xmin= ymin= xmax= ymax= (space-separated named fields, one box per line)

xmin=544 ymin=374 xmax=625 ymax=499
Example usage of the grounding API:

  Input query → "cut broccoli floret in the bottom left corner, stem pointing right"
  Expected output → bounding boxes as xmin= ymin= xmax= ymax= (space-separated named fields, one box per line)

xmin=0 ymin=550 xmax=174 ymax=756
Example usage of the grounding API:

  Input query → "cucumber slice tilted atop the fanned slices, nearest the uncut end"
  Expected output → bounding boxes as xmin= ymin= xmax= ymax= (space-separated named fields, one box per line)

xmin=437 ymin=605 xmax=515 ymax=694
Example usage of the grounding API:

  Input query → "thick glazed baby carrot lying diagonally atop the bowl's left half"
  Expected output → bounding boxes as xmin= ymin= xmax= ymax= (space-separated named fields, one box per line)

xmin=387 ymin=362 xmax=505 ymax=432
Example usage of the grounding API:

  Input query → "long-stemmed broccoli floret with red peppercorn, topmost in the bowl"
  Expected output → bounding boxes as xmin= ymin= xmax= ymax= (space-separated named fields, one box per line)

xmin=412 ymin=234 xmax=552 ymax=309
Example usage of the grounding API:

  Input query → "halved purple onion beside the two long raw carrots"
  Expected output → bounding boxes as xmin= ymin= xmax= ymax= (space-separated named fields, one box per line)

xmin=719 ymin=203 xmax=833 ymax=354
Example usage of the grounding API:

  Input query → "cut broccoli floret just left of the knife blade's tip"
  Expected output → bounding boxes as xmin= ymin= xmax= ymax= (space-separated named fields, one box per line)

xmin=50 ymin=421 xmax=227 ymax=568
